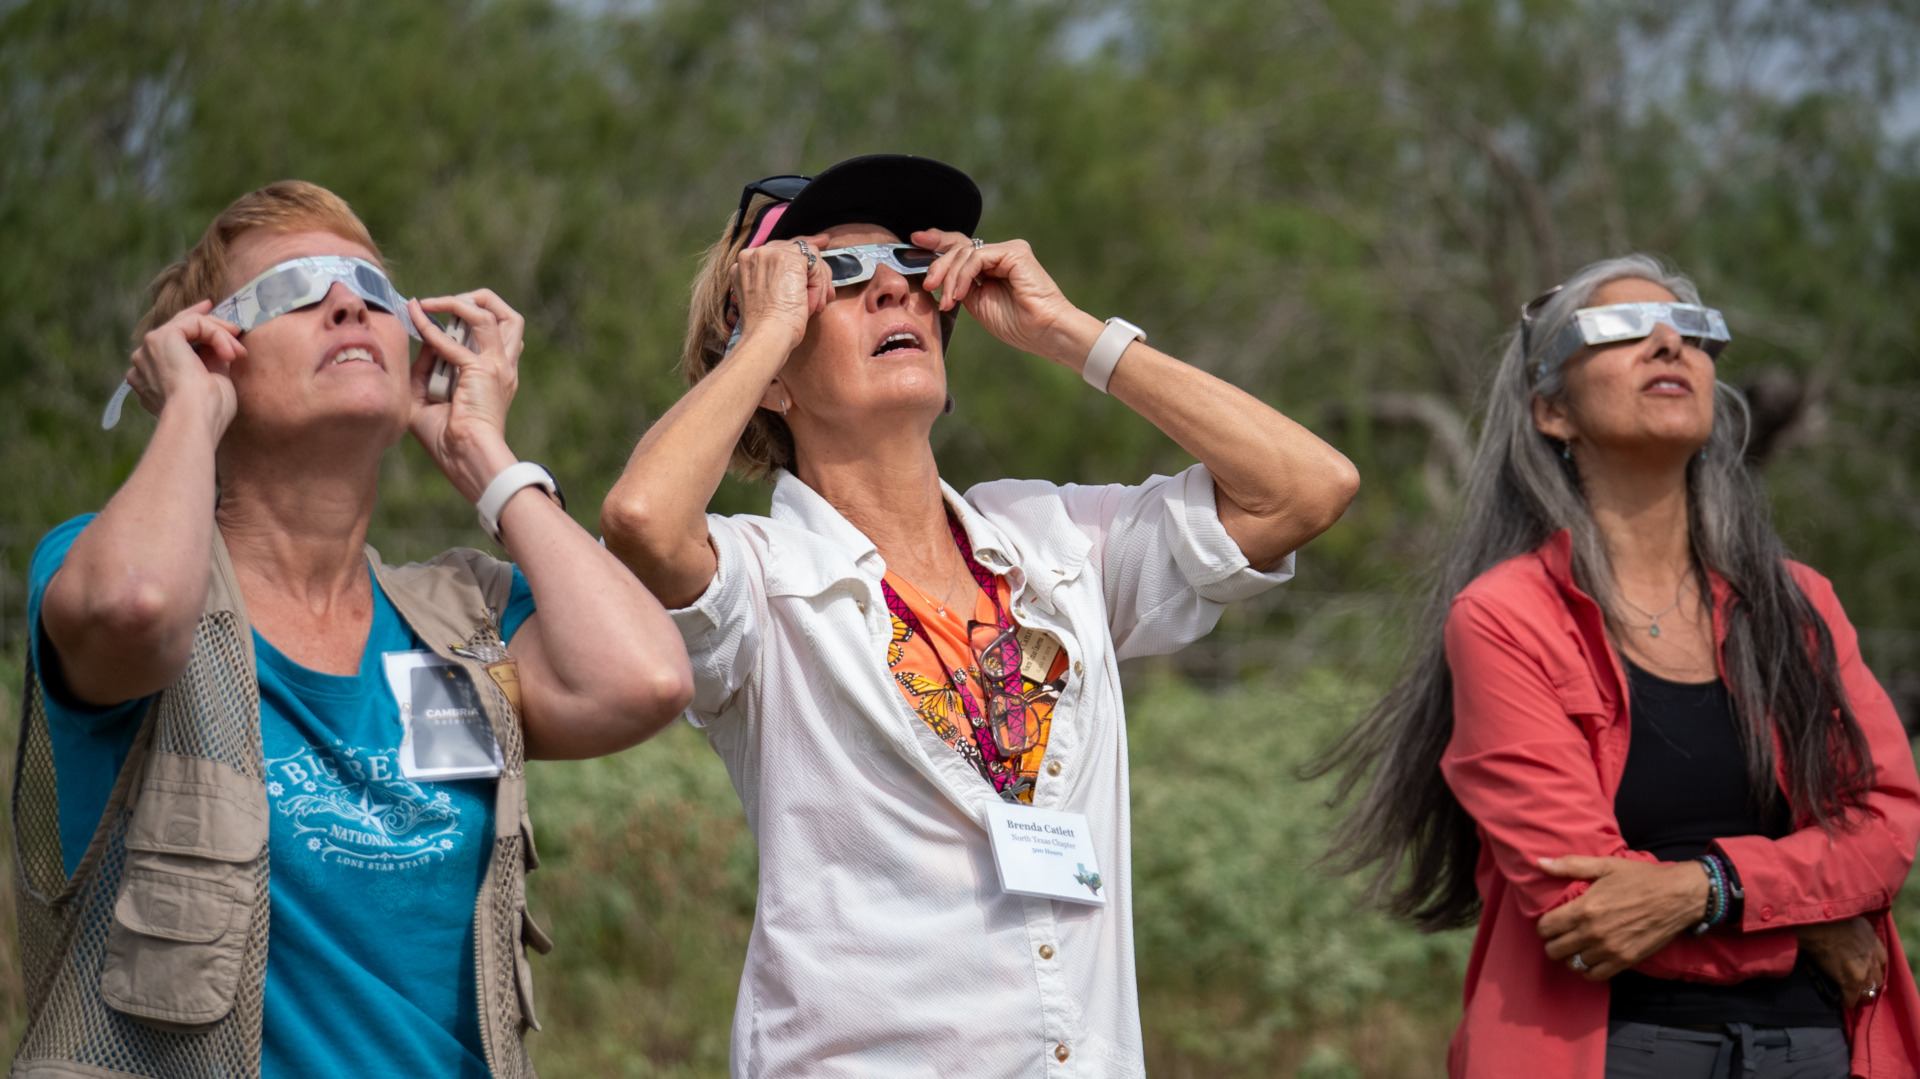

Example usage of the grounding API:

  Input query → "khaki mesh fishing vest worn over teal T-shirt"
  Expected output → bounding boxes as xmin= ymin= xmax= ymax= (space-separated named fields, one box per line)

xmin=13 ymin=534 xmax=553 ymax=1079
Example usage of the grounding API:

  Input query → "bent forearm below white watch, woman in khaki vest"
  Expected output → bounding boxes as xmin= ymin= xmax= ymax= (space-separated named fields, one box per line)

xmin=501 ymin=490 xmax=693 ymax=756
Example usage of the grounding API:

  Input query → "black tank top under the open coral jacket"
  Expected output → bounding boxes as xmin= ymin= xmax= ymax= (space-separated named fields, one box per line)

xmin=1609 ymin=662 xmax=1843 ymax=1027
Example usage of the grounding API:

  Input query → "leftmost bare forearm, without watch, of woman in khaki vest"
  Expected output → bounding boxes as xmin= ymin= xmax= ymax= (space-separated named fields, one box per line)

xmin=42 ymin=399 xmax=225 ymax=705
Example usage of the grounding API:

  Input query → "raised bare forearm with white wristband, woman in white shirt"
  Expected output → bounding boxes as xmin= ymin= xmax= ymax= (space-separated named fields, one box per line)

xmin=1052 ymin=313 xmax=1359 ymax=566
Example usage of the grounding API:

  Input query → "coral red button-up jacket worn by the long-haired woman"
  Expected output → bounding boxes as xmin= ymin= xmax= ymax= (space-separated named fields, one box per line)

xmin=1440 ymin=532 xmax=1920 ymax=1079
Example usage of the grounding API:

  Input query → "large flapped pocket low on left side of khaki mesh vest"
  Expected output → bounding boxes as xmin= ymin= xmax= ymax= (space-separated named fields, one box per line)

xmin=100 ymin=753 xmax=267 ymax=1027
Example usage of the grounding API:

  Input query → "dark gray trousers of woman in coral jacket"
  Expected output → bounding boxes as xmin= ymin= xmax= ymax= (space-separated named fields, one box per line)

xmin=1607 ymin=1023 xmax=1851 ymax=1079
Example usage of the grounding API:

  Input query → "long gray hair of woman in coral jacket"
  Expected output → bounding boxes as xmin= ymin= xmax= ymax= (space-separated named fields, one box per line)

xmin=1308 ymin=255 xmax=1870 ymax=929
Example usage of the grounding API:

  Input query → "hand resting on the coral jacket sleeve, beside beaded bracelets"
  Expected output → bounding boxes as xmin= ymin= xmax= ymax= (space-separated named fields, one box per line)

xmin=1540 ymin=854 xmax=1709 ymax=981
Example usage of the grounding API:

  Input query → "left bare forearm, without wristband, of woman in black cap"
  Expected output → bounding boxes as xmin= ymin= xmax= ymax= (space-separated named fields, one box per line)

xmin=601 ymin=328 xmax=793 ymax=607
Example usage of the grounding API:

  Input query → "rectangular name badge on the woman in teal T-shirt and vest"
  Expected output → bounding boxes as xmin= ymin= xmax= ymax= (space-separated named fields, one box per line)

xmin=380 ymin=651 xmax=501 ymax=779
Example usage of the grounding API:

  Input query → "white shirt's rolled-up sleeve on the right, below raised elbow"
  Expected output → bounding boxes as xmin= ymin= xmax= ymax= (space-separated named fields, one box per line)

xmin=1060 ymin=465 xmax=1294 ymax=659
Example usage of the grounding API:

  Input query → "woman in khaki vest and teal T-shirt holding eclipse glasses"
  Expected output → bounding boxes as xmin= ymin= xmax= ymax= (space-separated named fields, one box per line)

xmin=13 ymin=182 xmax=691 ymax=1077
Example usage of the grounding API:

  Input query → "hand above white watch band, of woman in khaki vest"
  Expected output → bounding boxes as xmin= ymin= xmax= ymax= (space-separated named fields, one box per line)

xmin=407 ymin=288 xmax=526 ymax=501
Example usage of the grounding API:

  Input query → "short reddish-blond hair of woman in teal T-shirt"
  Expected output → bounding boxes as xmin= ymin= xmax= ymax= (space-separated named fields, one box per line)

xmin=132 ymin=180 xmax=380 ymax=342
